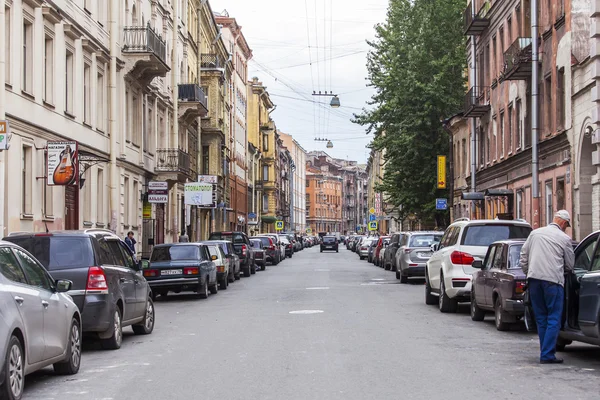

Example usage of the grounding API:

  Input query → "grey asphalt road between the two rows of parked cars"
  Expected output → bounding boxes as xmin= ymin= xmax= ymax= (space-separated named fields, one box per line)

xmin=24 ymin=246 xmax=600 ymax=400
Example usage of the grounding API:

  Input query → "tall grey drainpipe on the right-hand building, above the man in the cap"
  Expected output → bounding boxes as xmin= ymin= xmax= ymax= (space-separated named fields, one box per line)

xmin=531 ymin=0 xmax=540 ymax=229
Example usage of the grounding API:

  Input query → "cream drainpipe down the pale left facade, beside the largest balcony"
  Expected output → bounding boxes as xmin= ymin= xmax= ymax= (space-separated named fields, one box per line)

xmin=108 ymin=0 xmax=121 ymax=232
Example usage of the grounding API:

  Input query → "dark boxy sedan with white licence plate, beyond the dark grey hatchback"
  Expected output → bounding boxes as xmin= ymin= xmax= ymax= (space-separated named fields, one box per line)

xmin=144 ymin=243 xmax=219 ymax=299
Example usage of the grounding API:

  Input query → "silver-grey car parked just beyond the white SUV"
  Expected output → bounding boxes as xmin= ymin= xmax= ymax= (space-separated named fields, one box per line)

xmin=395 ymin=232 xmax=443 ymax=283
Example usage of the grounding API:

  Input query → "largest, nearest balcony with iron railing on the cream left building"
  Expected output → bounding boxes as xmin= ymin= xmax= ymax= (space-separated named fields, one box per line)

xmin=122 ymin=25 xmax=171 ymax=85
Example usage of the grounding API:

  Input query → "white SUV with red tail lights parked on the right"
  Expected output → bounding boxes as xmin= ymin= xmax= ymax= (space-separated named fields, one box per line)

xmin=425 ymin=218 xmax=531 ymax=312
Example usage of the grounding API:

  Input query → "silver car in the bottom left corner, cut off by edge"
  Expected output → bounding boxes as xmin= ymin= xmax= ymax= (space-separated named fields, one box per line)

xmin=0 ymin=241 xmax=81 ymax=399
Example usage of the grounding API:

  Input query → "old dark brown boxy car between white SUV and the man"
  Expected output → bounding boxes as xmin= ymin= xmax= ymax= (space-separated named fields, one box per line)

xmin=471 ymin=239 xmax=527 ymax=331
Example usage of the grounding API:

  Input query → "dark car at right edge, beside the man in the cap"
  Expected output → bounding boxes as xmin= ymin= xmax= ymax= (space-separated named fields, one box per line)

xmin=525 ymin=231 xmax=600 ymax=351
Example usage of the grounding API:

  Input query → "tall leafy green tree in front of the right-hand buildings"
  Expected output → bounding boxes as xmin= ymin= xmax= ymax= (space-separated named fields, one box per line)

xmin=354 ymin=0 xmax=466 ymax=225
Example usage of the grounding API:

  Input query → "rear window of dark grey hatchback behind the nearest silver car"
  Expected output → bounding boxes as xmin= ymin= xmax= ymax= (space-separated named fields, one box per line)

xmin=6 ymin=236 xmax=95 ymax=271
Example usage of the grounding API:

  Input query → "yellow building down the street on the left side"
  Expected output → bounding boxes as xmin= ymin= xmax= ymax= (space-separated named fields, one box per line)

xmin=247 ymin=78 xmax=279 ymax=232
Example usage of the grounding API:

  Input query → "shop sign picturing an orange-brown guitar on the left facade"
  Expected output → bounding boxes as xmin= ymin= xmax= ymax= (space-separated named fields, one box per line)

xmin=46 ymin=142 xmax=79 ymax=186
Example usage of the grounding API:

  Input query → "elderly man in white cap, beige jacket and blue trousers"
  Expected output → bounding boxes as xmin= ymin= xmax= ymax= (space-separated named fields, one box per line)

xmin=520 ymin=210 xmax=575 ymax=364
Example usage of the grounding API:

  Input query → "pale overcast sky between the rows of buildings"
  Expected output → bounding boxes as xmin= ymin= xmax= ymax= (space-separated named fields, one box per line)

xmin=210 ymin=0 xmax=388 ymax=163
